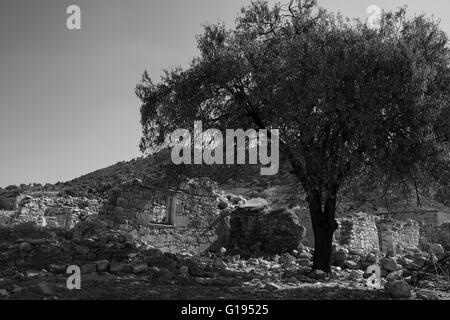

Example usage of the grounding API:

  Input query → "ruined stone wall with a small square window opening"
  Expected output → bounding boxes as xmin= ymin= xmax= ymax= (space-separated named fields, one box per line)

xmin=100 ymin=179 xmax=227 ymax=254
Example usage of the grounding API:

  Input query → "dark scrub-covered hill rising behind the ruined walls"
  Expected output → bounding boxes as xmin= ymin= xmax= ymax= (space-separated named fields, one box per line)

xmin=0 ymin=149 xmax=450 ymax=214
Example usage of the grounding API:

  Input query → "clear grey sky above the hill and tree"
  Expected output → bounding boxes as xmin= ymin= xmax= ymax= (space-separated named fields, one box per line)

xmin=0 ymin=0 xmax=450 ymax=187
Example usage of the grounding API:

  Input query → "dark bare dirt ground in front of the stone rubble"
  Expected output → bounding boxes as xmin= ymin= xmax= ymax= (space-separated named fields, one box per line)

xmin=0 ymin=274 xmax=450 ymax=300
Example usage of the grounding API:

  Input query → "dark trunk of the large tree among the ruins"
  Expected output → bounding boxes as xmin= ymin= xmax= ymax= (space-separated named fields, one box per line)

xmin=308 ymin=193 xmax=338 ymax=273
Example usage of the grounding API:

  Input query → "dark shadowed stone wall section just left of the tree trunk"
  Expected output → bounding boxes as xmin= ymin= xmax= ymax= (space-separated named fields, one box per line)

xmin=229 ymin=204 xmax=306 ymax=256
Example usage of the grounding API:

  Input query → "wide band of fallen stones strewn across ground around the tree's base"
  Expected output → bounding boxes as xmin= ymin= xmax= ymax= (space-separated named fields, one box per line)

xmin=0 ymin=218 xmax=444 ymax=299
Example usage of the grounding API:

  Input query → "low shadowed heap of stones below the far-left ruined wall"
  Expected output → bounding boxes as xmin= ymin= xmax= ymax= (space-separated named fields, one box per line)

xmin=0 ymin=216 xmax=141 ymax=269
